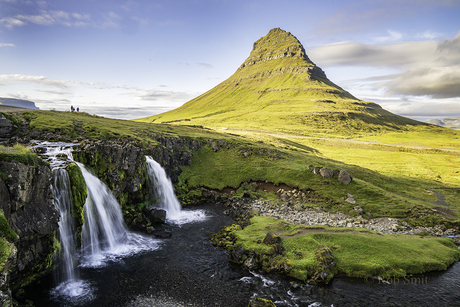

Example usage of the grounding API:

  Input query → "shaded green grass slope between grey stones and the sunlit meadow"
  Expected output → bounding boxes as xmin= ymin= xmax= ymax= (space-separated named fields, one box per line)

xmin=179 ymin=143 xmax=460 ymax=226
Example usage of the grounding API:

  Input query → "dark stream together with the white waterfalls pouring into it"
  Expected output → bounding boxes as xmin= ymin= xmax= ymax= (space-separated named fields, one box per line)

xmin=26 ymin=143 xmax=460 ymax=307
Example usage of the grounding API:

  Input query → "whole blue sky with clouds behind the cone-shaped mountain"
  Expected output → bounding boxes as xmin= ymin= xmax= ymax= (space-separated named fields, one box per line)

xmin=0 ymin=0 xmax=460 ymax=121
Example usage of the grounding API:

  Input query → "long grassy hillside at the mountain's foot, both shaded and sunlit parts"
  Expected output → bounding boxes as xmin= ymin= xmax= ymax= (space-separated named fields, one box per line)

xmin=1 ymin=111 xmax=460 ymax=229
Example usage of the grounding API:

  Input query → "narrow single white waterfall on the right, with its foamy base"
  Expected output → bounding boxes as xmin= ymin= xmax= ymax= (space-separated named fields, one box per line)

xmin=145 ymin=156 xmax=207 ymax=225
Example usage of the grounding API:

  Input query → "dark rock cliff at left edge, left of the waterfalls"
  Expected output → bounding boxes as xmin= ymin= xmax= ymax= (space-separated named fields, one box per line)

xmin=0 ymin=161 xmax=59 ymax=288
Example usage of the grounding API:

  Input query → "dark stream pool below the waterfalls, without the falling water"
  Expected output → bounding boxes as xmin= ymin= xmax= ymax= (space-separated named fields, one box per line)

xmin=26 ymin=204 xmax=460 ymax=307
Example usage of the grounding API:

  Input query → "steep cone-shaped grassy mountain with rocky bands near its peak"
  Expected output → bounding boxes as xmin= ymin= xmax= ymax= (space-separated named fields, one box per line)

xmin=137 ymin=28 xmax=434 ymax=136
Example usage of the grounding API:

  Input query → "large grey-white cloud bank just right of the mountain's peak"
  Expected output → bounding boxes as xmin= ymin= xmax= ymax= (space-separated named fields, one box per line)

xmin=309 ymin=32 xmax=460 ymax=98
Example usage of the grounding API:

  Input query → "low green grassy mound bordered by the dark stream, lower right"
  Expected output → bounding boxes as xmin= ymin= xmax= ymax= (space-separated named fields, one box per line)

xmin=226 ymin=217 xmax=460 ymax=280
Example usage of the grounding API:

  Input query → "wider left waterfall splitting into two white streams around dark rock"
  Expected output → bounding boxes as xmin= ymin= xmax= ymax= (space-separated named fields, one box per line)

xmin=36 ymin=142 xmax=160 ymax=303
